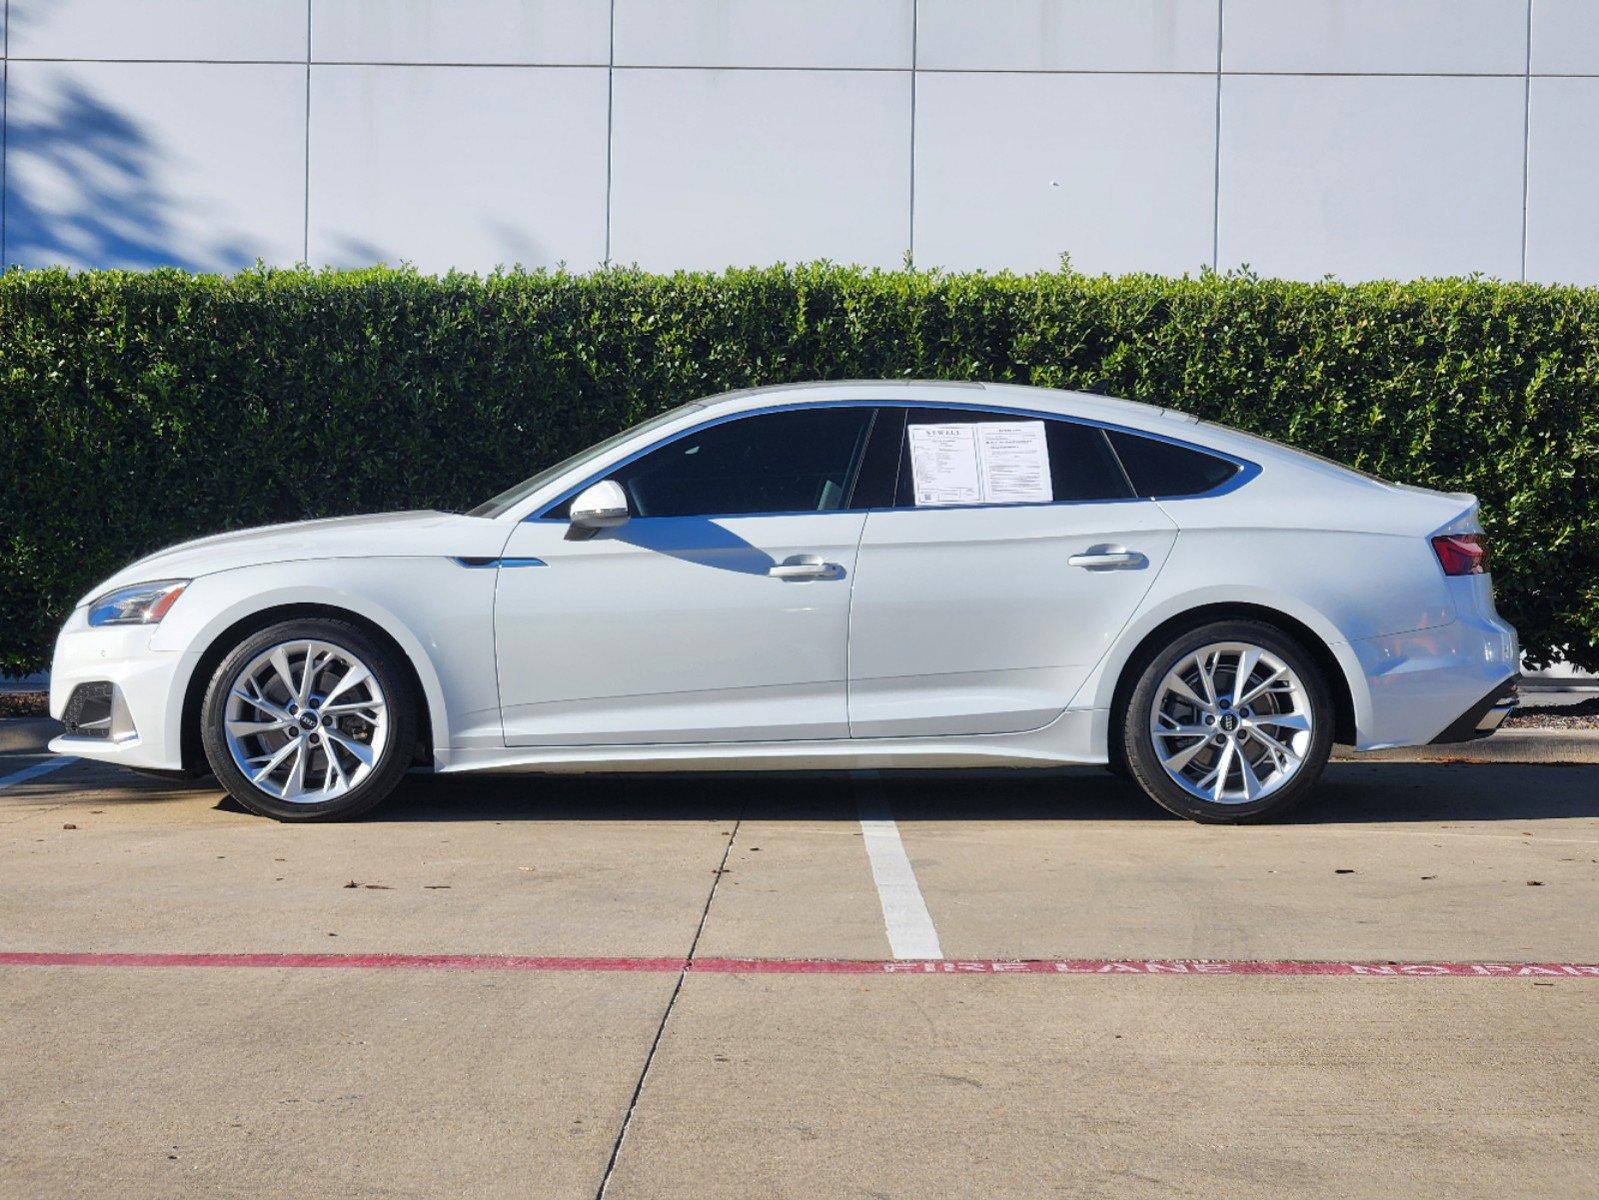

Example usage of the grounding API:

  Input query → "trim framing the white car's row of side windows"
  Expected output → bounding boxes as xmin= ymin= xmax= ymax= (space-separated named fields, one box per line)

xmin=523 ymin=397 xmax=1260 ymax=522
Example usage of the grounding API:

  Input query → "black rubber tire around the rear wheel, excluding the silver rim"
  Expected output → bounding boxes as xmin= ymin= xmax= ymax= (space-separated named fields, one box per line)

xmin=1113 ymin=621 xmax=1335 ymax=824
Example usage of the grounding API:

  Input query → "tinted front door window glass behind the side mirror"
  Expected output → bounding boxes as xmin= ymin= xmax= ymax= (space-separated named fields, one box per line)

xmin=611 ymin=406 xmax=871 ymax=517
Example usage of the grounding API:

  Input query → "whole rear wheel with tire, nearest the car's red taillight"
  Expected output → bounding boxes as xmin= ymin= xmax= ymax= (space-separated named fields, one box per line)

xmin=1121 ymin=621 xmax=1334 ymax=824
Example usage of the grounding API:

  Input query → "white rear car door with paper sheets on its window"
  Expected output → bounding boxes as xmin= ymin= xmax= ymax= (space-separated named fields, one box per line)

xmin=849 ymin=408 xmax=1177 ymax=738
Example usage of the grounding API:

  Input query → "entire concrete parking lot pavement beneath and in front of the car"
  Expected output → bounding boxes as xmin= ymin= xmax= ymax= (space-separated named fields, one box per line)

xmin=0 ymin=755 xmax=1599 ymax=1197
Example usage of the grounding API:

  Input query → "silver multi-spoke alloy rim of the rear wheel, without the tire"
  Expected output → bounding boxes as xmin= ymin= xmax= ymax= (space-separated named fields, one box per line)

xmin=1150 ymin=642 xmax=1314 ymax=805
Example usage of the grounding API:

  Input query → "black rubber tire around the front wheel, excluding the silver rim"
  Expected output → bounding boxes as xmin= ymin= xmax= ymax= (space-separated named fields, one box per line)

xmin=200 ymin=618 xmax=417 ymax=821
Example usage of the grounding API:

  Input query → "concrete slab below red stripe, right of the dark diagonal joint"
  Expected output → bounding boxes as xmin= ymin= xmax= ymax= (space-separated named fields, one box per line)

xmin=608 ymin=974 xmax=1599 ymax=1200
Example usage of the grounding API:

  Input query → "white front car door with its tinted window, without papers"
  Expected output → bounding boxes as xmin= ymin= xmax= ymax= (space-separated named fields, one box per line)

xmin=494 ymin=406 xmax=875 ymax=746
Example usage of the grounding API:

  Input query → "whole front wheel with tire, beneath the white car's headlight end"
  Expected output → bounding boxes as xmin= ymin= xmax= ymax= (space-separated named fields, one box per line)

xmin=200 ymin=619 xmax=416 ymax=821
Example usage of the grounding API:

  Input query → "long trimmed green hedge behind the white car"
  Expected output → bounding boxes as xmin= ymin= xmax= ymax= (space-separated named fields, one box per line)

xmin=0 ymin=266 xmax=1599 ymax=672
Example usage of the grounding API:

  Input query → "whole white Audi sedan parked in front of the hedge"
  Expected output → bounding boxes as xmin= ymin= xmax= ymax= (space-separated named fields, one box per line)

xmin=51 ymin=382 xmax=1519 ymax=821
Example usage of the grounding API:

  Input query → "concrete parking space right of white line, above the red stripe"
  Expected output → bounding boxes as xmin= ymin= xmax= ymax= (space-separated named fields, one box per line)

xmin=889 ymin=763 xmax=1599 ymax=962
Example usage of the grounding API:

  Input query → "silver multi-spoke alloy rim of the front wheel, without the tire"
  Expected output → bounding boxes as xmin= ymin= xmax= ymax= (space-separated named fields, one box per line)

xmin=222 ymin=640 xmax=389 ymax=805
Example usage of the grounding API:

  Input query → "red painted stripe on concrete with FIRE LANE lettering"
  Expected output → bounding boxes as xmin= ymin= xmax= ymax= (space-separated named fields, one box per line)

xmin=0 ymin=950 xmax=1599 ymax=979
